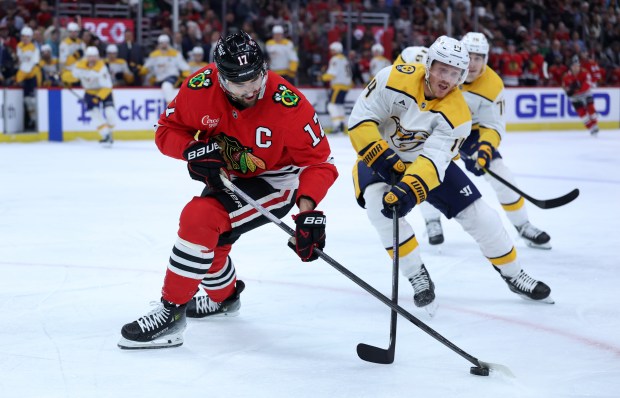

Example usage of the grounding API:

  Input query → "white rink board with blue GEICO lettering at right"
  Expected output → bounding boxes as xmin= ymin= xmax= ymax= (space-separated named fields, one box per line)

xmin=504 ymin=87 xmax=620 ymax=124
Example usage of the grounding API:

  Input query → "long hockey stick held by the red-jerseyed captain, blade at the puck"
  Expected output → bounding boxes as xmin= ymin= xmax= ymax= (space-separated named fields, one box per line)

xmin=222 ymin=177 xmax=514 ymax=377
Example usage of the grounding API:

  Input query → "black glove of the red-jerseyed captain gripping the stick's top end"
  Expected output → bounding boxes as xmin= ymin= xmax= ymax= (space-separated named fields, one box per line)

xmin=183 ymin=139 xmax=226 ymax=190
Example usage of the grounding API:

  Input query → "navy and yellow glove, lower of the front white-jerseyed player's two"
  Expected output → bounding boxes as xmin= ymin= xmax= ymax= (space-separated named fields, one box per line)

xmin=381 ymin=174 xmax=426 ymax=218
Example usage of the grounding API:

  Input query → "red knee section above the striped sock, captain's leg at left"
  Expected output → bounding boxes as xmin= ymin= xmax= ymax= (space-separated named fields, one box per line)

xmin=179 ymin=197 xmax=231 ymax=249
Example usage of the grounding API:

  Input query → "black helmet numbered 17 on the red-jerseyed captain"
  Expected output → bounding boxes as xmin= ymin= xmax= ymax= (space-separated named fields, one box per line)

xmin=214 ymin=31 xmax=267 ymax=83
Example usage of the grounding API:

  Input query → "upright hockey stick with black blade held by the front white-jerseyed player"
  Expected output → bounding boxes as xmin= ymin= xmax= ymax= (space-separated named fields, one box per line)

xmin=357 ymin=176 xmax=400 ymax=365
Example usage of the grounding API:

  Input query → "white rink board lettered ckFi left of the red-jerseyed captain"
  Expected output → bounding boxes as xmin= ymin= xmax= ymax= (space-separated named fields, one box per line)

xmin=62 ymin=88 xmax=174 ymax=132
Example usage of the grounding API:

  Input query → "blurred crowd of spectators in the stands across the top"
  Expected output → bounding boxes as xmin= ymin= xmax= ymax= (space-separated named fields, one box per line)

xmin=0 ymin=0 xmax=620 ymax=86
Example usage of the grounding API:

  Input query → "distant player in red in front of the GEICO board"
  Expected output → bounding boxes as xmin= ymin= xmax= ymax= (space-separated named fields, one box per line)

xmin=562 ymin=55 xmax=599 ymax=136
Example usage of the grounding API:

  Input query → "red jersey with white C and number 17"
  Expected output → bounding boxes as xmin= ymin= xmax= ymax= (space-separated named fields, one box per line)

xmin=155 ymin=64 xmax=338 ymax=204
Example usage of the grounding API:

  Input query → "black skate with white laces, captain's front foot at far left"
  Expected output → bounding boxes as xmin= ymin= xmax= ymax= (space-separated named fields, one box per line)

xmin=118 ymin=298 xmax=187 ymax=350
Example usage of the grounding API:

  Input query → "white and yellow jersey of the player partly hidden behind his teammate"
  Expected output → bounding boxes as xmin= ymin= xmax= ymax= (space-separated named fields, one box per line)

xmin=461 ymin=66 xmax=506 ymax=148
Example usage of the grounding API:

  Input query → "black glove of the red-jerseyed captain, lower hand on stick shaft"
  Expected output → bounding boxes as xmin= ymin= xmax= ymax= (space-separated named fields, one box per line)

xmin=288 ymin=210 xmax=326 ymax=262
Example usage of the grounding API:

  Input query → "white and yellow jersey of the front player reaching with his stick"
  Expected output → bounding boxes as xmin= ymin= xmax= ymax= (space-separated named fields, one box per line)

xmin=349 ymin=64 xmax=471 ymax=190
